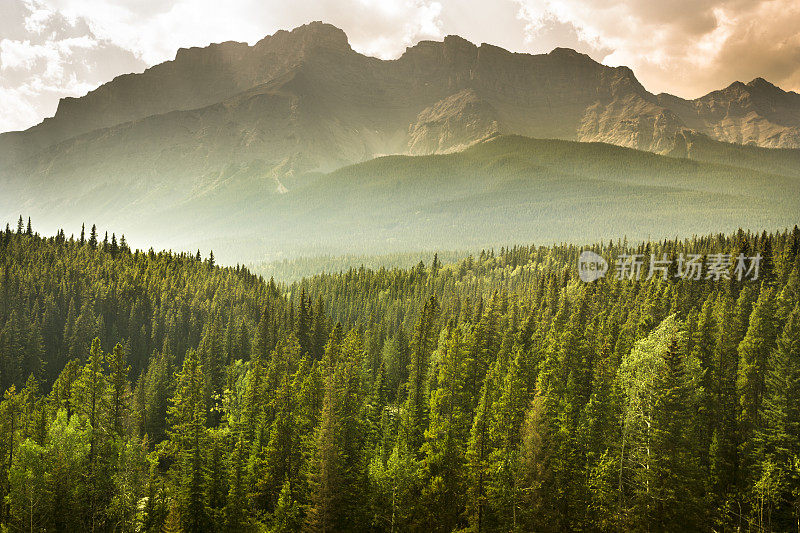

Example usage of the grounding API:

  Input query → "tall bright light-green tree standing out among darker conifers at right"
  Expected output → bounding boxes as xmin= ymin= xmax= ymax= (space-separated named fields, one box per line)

xmin=619 ymin=316 xmax=700 ymax=530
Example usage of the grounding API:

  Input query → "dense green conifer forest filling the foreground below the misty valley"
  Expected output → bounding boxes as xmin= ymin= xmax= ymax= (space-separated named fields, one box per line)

xmin=0 ymin=222 xmax=800 ymax=532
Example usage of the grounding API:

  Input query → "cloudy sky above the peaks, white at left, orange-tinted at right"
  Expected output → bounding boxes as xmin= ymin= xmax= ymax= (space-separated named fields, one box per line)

xmin=0 ymin=0 xmax=800 ymax=132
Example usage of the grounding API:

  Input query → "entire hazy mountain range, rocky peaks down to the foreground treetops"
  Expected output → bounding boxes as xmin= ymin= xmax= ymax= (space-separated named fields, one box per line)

xmin=0 ymin=22 xmax=800 ymax=257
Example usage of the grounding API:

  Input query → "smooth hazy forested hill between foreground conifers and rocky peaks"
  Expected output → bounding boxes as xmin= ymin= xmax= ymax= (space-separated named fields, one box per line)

xmin=266 ymin=136 xmax=800 ymax=254
